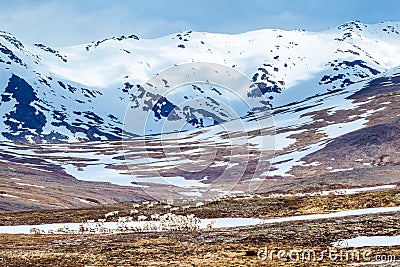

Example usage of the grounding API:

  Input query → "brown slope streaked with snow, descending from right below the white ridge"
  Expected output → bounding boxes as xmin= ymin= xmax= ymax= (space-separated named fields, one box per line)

xmin=1 ymin=64 xmax=400 ymax=205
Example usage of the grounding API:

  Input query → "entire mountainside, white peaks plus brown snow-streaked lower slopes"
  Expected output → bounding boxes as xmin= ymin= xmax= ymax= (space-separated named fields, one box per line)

xmin=0 ymin=21 xmax=400 ymax=209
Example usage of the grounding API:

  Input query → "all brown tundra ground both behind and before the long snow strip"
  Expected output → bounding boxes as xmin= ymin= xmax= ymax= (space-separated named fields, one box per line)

xmin=0 ymin=190 xmax=400 ymax=266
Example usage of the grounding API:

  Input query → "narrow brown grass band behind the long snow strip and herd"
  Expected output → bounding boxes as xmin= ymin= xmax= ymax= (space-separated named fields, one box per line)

xmin=0 ymin=190 xmax=400 ymax=225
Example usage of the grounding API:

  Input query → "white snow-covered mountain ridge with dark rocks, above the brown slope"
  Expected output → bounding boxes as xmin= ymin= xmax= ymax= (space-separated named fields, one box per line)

xmin=0 ymin=21 xmax=400 ymax=143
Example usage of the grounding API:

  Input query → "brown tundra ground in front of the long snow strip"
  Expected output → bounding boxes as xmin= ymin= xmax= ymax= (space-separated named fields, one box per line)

xmin=0 ymin=213 xmax=400 ymax=266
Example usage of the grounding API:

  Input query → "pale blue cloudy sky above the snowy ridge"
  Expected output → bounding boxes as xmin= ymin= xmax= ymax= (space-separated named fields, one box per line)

xmin=0 ymin=0 xmax=400 ymax=46
